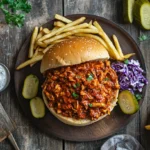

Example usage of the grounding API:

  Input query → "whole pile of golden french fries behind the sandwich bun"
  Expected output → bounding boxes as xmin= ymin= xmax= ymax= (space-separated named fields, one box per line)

xmin=16 ymin=14 xmax=134 ymax=70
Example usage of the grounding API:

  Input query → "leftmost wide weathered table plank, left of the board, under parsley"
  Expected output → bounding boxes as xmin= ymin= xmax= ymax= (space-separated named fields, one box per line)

xmin=0 ymin=0 xmax=63 ymax=150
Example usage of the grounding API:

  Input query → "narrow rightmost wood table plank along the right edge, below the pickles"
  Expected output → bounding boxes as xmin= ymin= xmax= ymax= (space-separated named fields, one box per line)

xmin=140 ymin=30 xmax=150 ymax=150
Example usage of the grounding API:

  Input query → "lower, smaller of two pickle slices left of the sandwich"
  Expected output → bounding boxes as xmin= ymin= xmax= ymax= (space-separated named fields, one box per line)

xmin=30 ymin=97 xmax=45 ymax=118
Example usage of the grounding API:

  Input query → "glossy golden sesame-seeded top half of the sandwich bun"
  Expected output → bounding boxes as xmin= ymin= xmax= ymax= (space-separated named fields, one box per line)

xmin=40 ymin=37 xmax=109 ymax=73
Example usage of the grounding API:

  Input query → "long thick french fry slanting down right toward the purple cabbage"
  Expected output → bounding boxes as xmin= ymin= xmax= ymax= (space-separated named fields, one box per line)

xmin=93 ymin=21 xmax=124 ymax=60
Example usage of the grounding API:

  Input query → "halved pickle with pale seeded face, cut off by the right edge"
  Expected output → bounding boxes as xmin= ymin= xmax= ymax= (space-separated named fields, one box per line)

xmin=134 ymin=0 xmax=150 ymax=30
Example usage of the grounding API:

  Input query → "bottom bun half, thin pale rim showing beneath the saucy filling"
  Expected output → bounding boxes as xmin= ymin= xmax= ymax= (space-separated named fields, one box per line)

xmin=42 ymin=91 xmax=119 ymax=126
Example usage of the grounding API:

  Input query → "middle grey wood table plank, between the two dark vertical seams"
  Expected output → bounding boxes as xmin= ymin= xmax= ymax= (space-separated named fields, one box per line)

xmin=64 ymin=0 xmax=146 ymax=150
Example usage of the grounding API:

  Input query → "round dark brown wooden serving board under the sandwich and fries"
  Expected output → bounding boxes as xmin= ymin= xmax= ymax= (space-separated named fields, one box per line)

xmin=15 ymin=14 xmax=146 ymax=141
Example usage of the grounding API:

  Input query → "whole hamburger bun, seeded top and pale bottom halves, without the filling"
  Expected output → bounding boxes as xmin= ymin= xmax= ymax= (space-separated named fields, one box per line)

xmin=40 ymin=37 xmax=119 ymax=126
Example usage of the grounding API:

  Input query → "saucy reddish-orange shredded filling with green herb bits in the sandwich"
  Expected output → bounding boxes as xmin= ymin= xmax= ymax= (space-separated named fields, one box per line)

xmin=42 ymin=60 xmax=120 ymax=120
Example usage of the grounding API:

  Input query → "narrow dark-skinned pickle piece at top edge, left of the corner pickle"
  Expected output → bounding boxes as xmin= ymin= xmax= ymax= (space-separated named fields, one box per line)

xmin=123 ymin=0 xmax=135 ymax=23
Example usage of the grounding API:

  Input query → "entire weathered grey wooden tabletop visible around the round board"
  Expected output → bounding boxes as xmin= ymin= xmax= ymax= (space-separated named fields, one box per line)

xmin=0 ymin=0 xmax=150 ymax=150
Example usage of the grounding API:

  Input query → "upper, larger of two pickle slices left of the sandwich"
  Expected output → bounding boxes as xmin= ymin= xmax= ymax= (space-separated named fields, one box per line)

xmin=22 ymin=74 xmax=39 ymax=99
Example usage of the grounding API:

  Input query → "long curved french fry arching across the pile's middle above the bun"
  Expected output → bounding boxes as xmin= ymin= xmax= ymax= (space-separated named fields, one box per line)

xmin=43 ymin=29 xmax=98 ymax=45
